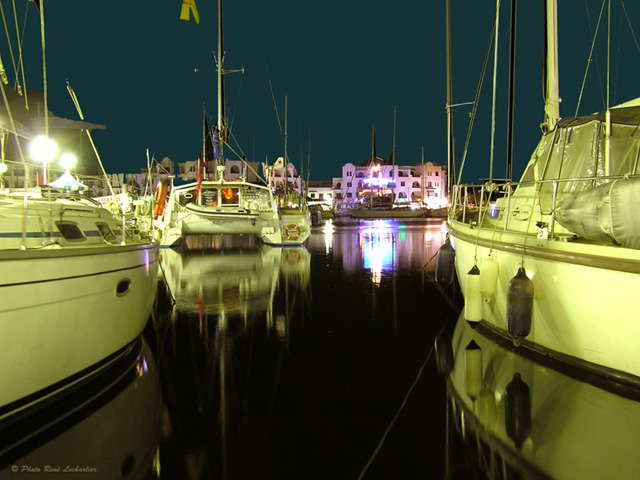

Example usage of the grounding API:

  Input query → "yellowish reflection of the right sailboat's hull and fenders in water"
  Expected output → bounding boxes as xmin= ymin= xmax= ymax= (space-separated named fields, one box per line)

xmin=436 ymin=316 xmax=640 ymax=480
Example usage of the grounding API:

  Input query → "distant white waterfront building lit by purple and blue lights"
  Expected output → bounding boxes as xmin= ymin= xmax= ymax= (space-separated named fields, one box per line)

xmin=333 ymin=156 xmax=447 ymax=212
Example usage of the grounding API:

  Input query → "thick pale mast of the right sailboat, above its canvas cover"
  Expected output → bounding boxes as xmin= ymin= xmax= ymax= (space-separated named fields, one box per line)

xmin=542 ymin=0 xmax=561 ymax=132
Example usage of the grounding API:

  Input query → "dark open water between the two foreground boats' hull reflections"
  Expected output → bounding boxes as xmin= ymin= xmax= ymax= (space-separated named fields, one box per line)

xmin=145 ymin=220 xmax=457 ymax=479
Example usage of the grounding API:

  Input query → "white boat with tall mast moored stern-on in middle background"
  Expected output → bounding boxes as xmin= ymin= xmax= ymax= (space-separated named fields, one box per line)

xmin=155 ymin=0 xmax=310 ymax=247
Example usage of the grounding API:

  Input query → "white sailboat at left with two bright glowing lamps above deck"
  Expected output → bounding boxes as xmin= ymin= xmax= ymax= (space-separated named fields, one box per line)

xmin=0 ymin=2 xmax=159 ymax=416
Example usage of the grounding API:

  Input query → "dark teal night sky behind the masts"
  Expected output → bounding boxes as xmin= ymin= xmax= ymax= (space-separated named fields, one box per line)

xmin=8 ymin=0 xmax=640 ymax=181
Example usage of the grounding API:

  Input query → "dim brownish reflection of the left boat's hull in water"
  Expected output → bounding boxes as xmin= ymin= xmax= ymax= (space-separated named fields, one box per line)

xmin=0 ymin=337 xmax=162 ymax=479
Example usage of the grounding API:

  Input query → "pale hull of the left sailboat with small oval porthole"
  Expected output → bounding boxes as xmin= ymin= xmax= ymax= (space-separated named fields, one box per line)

xmin=0 ymin=244 xmax=158 ymax=409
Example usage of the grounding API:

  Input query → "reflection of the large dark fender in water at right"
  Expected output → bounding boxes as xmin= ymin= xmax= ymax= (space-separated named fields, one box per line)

xmin=504 ymin=373 xmax=531 ymax=448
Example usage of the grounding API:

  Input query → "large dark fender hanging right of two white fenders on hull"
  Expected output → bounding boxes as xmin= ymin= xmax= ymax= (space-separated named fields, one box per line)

xmin=507 ymin=267 xmax=533 ymax=346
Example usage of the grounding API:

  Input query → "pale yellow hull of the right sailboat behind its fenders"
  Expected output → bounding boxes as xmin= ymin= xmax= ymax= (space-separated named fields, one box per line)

xmin=449 ymin=221 xmax=640 ymax=384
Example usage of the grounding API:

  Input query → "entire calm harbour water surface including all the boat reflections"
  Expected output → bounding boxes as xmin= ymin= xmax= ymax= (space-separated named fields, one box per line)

xmin=0 ymin=220 xmax=640 ymax=480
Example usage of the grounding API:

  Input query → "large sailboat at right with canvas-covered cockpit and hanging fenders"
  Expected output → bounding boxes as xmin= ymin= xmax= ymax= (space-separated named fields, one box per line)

xmin=438 ymin=0 xmax=640 ymax=386
